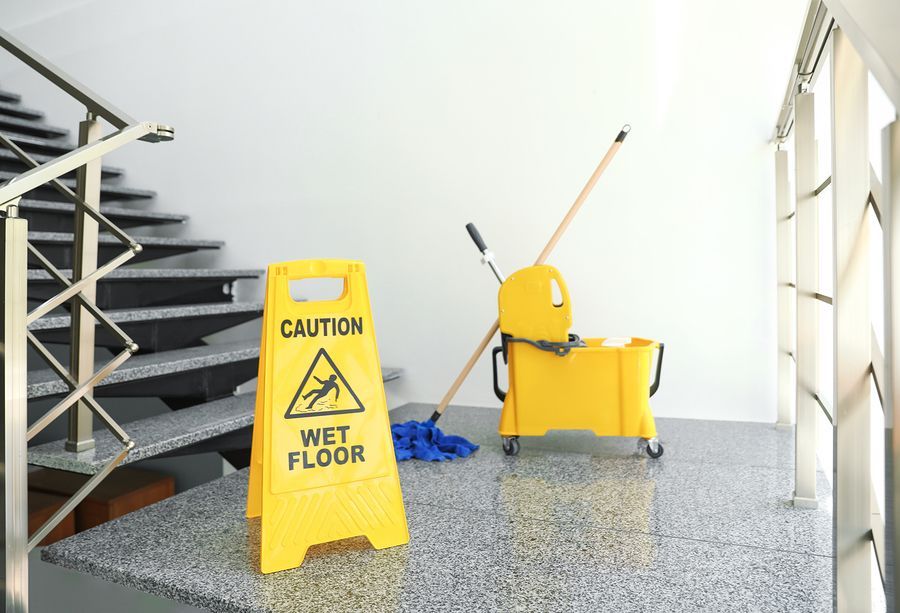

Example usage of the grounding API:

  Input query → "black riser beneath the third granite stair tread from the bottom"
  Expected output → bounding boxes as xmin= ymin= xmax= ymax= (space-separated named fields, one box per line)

xmin=34 ymin=312 xmax=261 ymax=353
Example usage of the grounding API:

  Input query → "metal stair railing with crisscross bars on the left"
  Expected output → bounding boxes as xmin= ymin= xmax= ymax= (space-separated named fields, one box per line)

xmin=0 ymin=25 xmax=175 ymax=612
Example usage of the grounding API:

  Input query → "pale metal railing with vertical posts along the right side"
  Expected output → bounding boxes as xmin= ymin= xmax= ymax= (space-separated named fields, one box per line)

xmin=773 ymin=0 xmax=900 ymax=611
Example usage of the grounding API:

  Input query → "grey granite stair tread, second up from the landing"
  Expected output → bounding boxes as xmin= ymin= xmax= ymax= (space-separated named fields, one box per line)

xmin=28 ymin=341 xmax=259 ymax=399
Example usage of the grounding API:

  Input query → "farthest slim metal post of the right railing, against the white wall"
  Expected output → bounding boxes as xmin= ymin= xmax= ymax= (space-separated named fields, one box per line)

xmin=775 ymin=147 xmax=796 ymax=427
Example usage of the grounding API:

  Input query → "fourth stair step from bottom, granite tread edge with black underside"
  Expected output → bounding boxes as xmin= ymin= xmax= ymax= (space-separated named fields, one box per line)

xmin=28 ymin=268 xmax=264 ymax=309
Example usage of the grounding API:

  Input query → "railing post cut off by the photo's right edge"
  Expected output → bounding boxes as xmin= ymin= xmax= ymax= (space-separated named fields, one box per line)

xmin=878 ymin=120 xmax=900 ymax=611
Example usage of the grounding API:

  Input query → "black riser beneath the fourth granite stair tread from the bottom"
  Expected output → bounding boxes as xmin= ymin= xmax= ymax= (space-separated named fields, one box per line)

xmin=28 ymin=278 xmax=241 ymax=309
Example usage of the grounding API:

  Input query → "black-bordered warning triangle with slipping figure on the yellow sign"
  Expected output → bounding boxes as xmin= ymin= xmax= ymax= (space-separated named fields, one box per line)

xmin=284 ymin=348 xmax=365 ymax=419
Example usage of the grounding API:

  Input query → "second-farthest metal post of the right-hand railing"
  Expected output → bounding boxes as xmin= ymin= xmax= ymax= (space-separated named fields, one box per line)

xmin=794 ymin=87 xmax=819 ymax=509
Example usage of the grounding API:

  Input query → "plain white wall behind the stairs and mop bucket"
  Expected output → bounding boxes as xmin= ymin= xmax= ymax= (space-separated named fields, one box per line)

xmin=0 ymin=0 xmax=805 ymax=421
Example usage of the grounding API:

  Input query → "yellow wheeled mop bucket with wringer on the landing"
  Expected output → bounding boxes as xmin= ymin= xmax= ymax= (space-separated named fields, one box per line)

xmin=493 ymin=265 xmax=664 ymax=458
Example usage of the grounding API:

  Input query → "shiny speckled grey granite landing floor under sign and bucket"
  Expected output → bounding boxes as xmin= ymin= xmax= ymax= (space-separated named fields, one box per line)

xmin=43 ymin=405 xmax=832 ymax=611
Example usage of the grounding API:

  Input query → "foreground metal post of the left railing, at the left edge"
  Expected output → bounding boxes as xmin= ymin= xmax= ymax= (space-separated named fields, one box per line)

xmin=0 ymin=204 xmax=28 ymax=612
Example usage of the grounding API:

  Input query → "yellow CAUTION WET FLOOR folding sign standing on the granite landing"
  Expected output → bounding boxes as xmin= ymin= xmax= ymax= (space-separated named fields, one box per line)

xmin=247 ymin=260 xmax=409 ymax=573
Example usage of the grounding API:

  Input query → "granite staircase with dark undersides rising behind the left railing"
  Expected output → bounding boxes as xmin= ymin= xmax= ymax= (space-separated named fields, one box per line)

xmin=0 ymin=80 xmax=400 ymax=524
